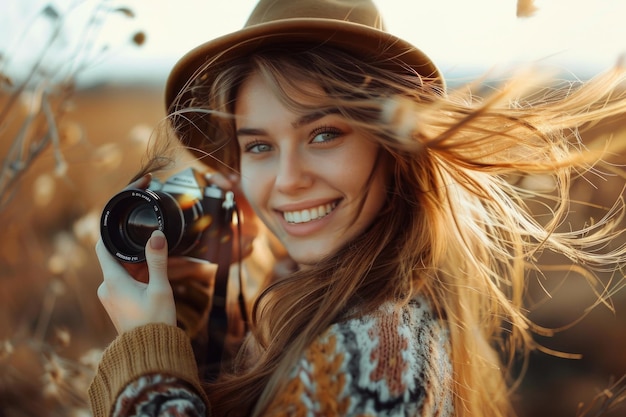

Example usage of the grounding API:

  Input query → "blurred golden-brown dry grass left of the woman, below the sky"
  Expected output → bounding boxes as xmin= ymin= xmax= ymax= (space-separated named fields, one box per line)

xmin=0 ymin=83 xmax=162 ymax=416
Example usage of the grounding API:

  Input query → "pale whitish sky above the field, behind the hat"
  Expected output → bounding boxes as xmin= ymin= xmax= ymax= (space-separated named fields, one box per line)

xmin=0 ymin=0 xmax=626 ymax=85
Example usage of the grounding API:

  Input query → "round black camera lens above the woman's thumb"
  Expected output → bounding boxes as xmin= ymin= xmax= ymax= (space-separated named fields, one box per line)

xmin=100 ymin=189 xmax=184 ymax=263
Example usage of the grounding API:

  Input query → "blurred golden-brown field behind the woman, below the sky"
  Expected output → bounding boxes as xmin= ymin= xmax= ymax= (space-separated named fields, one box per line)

xmin=0 ymin=1 xmax=626 ymax=417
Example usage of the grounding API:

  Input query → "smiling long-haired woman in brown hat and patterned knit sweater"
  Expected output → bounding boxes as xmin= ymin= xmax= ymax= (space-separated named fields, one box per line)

xmin=90 ymin=0 xmax=626 ymax=416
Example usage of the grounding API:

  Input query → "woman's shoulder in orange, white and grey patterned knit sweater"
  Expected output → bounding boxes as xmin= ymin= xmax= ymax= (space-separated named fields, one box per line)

xmin=266 ymin=299 xmax=452 ymax=416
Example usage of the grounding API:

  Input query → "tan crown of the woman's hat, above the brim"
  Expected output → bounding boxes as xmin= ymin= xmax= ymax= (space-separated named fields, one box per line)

xmin=245 ymin=0 xmax=384 ymax=30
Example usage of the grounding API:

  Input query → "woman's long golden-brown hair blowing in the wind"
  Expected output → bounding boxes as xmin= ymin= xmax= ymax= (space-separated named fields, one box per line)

xmin=161 ymin=47 xmax=626 ymax=417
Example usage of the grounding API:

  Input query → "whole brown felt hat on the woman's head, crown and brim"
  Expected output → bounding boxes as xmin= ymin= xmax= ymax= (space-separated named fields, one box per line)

xmin=165 ymin=0 xmax=445 ymax=163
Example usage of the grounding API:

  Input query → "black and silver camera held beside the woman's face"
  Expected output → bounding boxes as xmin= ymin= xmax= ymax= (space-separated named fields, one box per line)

xmin=100 ymin=168 xmax=235 ymax=263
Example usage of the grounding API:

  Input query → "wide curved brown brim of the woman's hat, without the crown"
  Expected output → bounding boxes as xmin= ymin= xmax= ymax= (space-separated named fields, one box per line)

xmin=165 ymin=18 xmax=445 ymax=168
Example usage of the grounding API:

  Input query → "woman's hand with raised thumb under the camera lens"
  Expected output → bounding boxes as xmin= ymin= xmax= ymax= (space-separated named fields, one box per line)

xmin=96 ymin=230 xmax=176 ymax=333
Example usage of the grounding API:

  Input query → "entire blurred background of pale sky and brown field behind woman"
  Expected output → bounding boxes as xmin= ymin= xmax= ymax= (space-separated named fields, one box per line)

xmin=0 ymin=0 xmax=626 ymax=417
